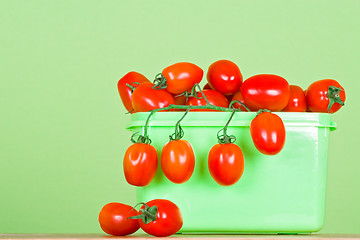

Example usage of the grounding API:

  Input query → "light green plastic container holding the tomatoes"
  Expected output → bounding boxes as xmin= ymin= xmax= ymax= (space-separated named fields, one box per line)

xmin=128 ymin=112 xmax=336 ymax=234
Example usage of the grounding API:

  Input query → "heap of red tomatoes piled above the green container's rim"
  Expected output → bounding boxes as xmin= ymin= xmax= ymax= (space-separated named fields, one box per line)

xmin=117 ymin=60 xmax=345 ymax=113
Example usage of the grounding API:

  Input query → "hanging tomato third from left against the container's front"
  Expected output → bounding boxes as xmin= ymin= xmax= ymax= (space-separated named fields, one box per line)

xmin=208 ymin=143 xmax=244 ymax=186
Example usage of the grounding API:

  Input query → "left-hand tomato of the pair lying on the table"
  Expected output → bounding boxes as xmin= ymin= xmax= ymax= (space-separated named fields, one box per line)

xmin=99 ymin=202 xmax=140 ymax=236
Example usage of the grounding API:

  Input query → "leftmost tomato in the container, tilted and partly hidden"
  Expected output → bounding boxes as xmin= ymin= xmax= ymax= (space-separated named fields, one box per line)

xmin=117 ymin=72 xmax=150 ymax=113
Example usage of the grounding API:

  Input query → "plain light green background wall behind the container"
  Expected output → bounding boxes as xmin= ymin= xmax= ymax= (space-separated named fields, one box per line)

xmin=0 ymin=0 xmax=360 ymax=233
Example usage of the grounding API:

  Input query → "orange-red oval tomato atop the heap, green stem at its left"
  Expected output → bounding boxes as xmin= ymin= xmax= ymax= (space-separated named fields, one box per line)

xmin=162 ymin=62 xmax=204 ymax=94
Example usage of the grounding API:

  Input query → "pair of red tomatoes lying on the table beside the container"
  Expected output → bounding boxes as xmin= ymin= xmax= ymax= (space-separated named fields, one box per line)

xmin=98 ymin=199 xmax=183 ymax=237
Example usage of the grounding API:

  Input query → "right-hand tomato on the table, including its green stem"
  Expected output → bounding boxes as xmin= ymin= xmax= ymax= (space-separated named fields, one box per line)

xmin=133 ymin=199 xmax=183 ymax=237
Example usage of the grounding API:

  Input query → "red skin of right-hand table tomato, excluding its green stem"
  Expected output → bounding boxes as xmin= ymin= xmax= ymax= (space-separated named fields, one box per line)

xmin=139 ymin=199 xmax=183 ymax=237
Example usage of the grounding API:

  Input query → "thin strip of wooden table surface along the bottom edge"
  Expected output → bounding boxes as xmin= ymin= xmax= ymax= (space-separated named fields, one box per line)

xmin=0 ymin=234 xmax=360 ymax=240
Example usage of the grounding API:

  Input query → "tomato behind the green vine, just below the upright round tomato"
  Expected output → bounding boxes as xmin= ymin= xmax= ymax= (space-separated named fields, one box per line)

xmin=187 ymin=90 xmax=229 ymax=111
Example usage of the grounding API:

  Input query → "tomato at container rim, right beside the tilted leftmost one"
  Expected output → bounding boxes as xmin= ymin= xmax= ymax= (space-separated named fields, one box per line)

xmin=131 ymin=83 xmax=175 ymax=112
